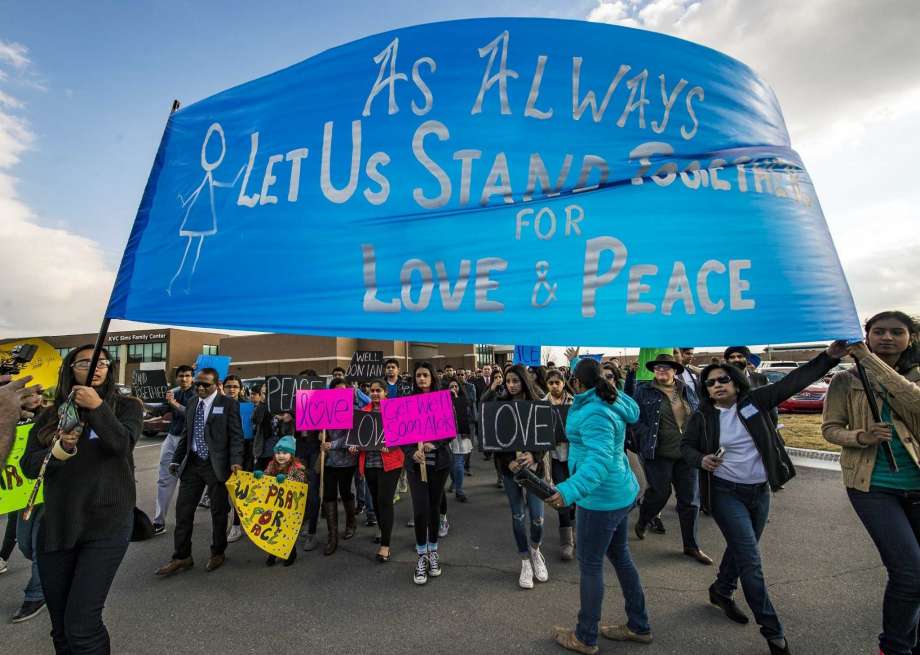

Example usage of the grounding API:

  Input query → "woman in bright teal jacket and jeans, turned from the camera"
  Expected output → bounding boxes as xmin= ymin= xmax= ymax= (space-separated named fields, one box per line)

xmin=546 ymin=359 xmax=652 ymax=655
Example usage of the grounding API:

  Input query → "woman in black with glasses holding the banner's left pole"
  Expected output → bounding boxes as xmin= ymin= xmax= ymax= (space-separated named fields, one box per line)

xmin=20 ymin=345 xmax=144 ymax=653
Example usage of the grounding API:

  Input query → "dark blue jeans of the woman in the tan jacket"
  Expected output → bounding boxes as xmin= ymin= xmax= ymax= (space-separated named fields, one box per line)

xmin=847 ymin=487 xmax=920 ymax=655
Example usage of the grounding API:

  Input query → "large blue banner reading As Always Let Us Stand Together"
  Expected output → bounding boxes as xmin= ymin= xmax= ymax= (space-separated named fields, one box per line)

xmin=107 ymin=18 xmax=860 ymax=346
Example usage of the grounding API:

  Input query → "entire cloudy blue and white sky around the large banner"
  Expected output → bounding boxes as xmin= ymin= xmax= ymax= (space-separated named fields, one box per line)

xmin=0 ymin=0 xmax=920 ymax=346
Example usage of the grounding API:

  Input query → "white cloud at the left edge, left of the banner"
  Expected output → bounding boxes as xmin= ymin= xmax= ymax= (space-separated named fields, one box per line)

xmin=0 ymin=41 xmax=114 ymax=336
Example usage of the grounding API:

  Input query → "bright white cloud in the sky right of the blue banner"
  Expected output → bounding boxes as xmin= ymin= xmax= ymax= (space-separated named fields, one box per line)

xmin=588 ymin=0 xmax=920 ymax=315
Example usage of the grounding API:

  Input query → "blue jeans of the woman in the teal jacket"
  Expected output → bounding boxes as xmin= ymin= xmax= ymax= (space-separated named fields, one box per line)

xmin=575 ymin=505 xmax=652 ymax=646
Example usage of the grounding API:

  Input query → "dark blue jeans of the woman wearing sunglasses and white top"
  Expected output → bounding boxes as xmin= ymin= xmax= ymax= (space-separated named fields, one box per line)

xmin=710 ymin=476 xmax=784 ymax=640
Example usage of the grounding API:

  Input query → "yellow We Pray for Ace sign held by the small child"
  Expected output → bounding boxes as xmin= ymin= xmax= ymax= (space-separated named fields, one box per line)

xmin=225 ymin=471 xmax=308 ymax=558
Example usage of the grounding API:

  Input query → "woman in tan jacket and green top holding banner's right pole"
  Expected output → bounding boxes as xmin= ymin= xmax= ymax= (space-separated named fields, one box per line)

xmin=821 ymin=311 xmax=920 ymax=655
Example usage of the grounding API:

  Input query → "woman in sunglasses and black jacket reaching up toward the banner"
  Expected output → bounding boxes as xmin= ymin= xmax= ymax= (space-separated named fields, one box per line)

xmin=681 ymin=341 xmax=847 ymax=655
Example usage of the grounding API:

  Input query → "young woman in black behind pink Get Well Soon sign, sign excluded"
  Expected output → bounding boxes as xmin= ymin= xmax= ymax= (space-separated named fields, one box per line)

xmin=403 ymin=362 xmax=451 ymax=585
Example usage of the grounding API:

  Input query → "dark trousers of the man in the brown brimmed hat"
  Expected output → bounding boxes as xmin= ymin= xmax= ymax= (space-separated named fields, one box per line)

xmin=639 ymin=457 xmax=700 ymax=550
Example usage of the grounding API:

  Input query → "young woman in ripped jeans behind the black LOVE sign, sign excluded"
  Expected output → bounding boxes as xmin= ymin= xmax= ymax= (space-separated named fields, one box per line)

xmin=482 ymin=364 xmax=549 ymax=589
